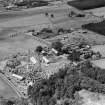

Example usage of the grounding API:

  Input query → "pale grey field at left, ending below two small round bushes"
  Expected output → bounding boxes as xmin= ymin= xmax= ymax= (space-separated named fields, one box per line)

xmin=0 ymin=14 xmax=50 ymax=28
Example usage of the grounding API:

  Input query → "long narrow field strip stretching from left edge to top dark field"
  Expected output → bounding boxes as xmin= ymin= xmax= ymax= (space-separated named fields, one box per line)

xmin=0 ymin=5 xmax=71 ymax=22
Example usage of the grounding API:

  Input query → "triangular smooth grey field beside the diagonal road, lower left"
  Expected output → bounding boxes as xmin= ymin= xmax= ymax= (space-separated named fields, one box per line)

xmin=0 ymin=74 xmax=18 ymax=98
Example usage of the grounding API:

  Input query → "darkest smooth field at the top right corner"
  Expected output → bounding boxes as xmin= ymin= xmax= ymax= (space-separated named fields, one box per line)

xmin=68 ymin=0 xmax=105 ymax=10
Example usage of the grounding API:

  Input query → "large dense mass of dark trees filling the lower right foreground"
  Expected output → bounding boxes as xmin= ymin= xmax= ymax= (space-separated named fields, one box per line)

xmin=30 ymin=61 xmax=105 ymax=105
